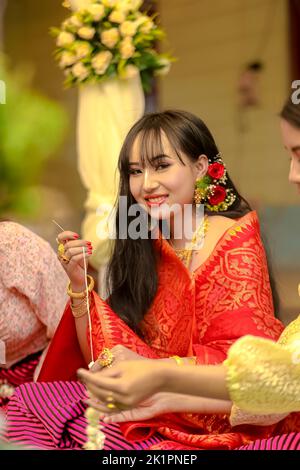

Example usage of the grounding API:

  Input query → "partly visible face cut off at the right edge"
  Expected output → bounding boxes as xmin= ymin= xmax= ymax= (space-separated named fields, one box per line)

xmin=280 ymin=119 xmax=300 ymax=194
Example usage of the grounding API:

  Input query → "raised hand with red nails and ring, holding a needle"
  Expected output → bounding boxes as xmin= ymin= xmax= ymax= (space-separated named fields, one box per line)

xmin=57 ymin=231 xmax=93 ymax=292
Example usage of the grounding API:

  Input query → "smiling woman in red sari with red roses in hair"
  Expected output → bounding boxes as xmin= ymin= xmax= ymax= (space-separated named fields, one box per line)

xmin=8 ymin=111 xmax=282 ymax=449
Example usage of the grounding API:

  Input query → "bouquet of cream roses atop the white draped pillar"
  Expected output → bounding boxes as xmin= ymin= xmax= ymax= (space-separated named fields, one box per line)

xmin=52 ymin=0 xmax=173 ymax=91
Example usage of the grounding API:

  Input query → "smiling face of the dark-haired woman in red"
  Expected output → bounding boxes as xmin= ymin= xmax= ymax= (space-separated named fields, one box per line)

xmin=129 ymin=132 xmax=208 ymax=219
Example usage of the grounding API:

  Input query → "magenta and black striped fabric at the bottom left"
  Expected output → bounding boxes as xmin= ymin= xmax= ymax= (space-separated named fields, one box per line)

xmin=6 ymin=382 xmax=162 ymax=450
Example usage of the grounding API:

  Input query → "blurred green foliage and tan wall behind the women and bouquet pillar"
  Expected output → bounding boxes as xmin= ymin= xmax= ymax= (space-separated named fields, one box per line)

xmin=0 ymin=0 xmax=300 ymax=323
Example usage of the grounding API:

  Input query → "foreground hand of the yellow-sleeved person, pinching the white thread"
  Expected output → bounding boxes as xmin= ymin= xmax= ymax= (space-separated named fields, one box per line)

xmin=78 ymin=358 xmax=166 ymax=407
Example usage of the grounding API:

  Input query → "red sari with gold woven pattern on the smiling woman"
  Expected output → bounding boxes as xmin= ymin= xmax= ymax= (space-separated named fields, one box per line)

xmin=39 ymin=212 xmax=283 ymax=449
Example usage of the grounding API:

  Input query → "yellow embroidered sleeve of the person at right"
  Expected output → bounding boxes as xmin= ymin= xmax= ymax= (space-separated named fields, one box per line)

xmin=224 ymin=316 xmax=300 ymax=416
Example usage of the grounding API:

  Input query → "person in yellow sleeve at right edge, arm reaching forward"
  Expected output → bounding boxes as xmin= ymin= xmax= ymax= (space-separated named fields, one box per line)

xmin=79 ymin=99 xmax=300 ymax=450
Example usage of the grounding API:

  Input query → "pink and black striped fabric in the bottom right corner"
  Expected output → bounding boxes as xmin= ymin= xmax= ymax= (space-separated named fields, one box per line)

xmin=238 ymin=432 xmax=300 ymax=450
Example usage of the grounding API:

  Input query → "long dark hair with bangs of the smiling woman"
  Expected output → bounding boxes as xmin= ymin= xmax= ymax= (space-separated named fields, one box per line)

xmin=107 ymin=111 xmax=276 ymax=334
